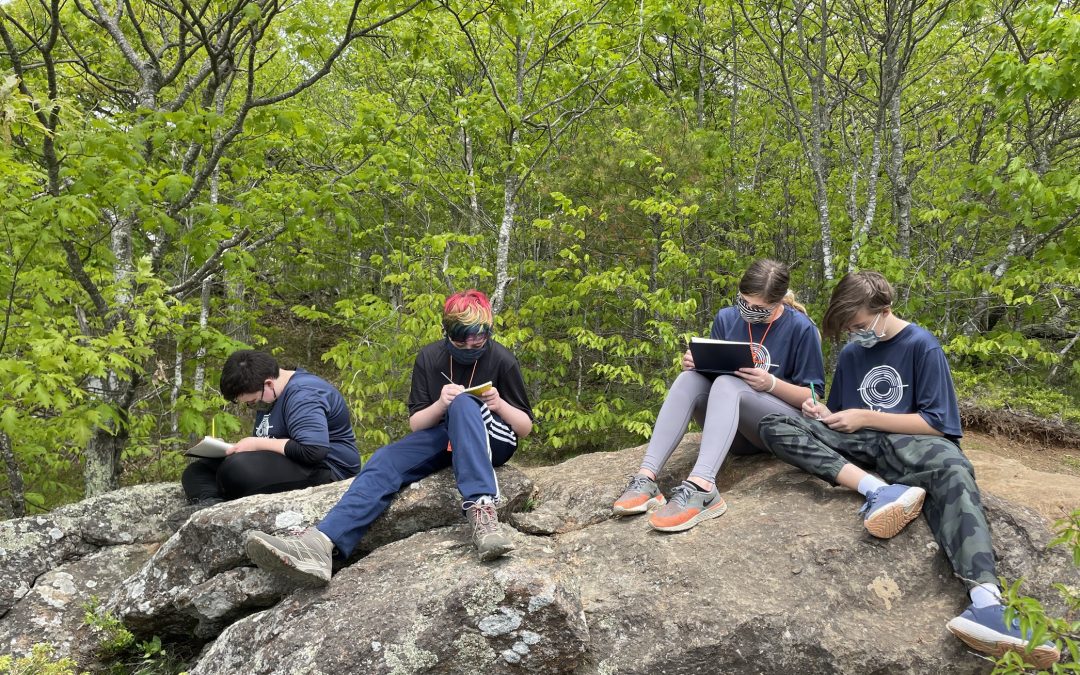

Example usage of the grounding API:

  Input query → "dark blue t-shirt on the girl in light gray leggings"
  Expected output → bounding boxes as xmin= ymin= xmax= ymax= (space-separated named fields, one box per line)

xmin=708 ymin=305 xmax=825 ymax=395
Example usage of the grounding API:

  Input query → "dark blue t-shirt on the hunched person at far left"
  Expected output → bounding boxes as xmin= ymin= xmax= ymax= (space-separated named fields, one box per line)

xmin=254 ymin=368 xmax=360 ymax=481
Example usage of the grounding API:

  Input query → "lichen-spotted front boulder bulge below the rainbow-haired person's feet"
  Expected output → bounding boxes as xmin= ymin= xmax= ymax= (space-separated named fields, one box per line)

xmin=191 ymin=526 xmax=589 ymax=675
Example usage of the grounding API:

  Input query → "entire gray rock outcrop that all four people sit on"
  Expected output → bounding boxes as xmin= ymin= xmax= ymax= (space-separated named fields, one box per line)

xmin=0 ymin=435 xmax=1080 ymax=675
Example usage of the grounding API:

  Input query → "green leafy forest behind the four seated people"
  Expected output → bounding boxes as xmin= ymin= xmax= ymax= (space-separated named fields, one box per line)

xmin=0 ymin=0 xmax=1080 ymax=509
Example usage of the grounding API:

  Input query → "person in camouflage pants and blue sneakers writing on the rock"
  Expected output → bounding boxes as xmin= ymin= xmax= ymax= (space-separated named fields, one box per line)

xmin=760 ymin=271 xmax=1061 ymax=667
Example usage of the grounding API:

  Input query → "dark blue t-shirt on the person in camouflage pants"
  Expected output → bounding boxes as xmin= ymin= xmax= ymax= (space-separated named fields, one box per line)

xmin=827 ymin=323 xmax=963 ymax=441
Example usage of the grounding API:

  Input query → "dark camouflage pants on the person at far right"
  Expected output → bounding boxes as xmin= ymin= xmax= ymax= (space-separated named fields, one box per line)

xmin=758 ymin=415 xmax=998 ymax=585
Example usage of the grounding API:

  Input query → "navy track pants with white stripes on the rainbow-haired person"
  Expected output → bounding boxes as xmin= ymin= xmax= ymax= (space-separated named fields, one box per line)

xmin=316 ymin=394 xmax=517 ymax=557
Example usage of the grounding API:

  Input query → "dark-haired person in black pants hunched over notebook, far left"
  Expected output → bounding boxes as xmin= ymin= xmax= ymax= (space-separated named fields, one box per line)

xmin=180 ymin=349 xmax=360 ymax=505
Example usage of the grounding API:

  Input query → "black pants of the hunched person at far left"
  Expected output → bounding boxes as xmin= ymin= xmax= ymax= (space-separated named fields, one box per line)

xmin=180 ymin=450 xmax=334 ymax=500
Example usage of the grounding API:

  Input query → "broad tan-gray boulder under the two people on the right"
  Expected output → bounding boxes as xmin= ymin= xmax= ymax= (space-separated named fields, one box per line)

xmin=181 ymin=438 xmax=1080 ymax=675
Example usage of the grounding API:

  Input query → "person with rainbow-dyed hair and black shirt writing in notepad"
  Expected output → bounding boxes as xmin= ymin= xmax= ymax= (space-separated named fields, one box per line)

xmin=246 ymin=289 xmax=532 ymax=585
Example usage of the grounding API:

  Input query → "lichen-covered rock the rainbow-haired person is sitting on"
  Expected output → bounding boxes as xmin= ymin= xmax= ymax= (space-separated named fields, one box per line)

xmin=105 ymin=467 xmax=532 ymax=639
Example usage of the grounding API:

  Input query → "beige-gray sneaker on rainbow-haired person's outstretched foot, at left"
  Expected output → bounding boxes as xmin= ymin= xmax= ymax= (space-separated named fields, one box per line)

xmin=244 ymin=527 xmax=334 ymax=586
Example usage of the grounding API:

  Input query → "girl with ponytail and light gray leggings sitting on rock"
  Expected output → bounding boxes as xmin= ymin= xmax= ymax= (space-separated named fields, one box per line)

xmin=611 ymin=260 xmax=825 ymax=531
